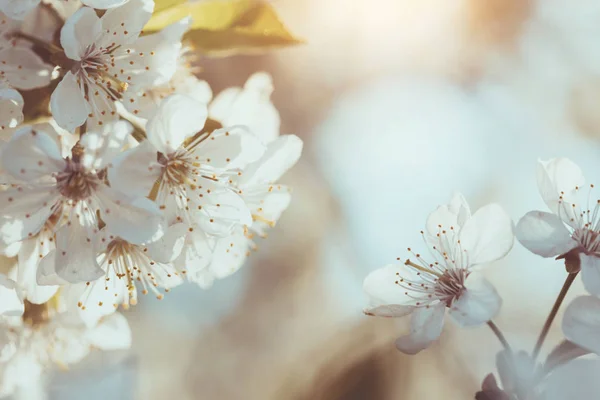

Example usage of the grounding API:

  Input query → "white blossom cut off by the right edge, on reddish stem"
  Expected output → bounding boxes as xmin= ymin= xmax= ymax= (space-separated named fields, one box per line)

xmin=516 ymin=158 xmax=600 ymax=295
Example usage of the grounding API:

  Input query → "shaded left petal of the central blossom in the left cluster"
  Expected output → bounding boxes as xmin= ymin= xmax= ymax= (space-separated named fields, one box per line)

xmin=108 ymin=140 xmax=162 ymax=196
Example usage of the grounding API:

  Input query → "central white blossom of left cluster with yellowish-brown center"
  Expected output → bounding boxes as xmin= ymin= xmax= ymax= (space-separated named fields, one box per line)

xmin=108 ymin=95 xmax=264 ymax=237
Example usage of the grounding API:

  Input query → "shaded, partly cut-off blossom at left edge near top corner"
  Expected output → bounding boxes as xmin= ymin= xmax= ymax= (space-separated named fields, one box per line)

xmin=0 ymin=11 xmax=53 ymax=90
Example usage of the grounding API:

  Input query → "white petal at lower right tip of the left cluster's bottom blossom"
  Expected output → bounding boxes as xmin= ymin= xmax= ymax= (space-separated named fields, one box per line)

xmin=86 ymin=313 xmax=131 ymax=350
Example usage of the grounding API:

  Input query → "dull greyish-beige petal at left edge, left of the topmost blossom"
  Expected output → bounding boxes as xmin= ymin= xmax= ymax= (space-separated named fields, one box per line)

xmin=0 ymin=46 xmax=53 ymax=90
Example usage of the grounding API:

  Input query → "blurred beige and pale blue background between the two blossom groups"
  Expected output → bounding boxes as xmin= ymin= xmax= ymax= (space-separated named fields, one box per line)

xmin=61 ymin=0 xmax=600 ymax=400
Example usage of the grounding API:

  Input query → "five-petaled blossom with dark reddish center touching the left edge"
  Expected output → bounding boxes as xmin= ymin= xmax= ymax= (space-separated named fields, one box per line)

xmin=0 ymin=122 xmax=163 ymax=282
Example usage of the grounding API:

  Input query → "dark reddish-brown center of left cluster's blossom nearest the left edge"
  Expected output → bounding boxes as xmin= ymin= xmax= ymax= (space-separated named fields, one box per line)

xmin=56 ymin=160 xmax=100 ymax=201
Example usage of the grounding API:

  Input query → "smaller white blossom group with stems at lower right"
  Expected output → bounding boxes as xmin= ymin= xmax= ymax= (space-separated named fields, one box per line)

xmin=364 ymin=158 xmax=600 ymax=400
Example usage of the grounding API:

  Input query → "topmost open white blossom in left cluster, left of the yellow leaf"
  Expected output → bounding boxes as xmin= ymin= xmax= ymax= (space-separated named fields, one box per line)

xmin=50 ymin=0 xmax=181 ymax=130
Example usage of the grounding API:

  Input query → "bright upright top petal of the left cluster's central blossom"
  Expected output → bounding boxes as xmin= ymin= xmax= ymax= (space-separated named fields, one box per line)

xmin=146 ymin=95 xmax=206 ymax=154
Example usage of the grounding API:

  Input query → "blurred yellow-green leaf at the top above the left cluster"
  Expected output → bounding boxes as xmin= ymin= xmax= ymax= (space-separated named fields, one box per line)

xmin=144 ymin=0 xmax=303 ymax=56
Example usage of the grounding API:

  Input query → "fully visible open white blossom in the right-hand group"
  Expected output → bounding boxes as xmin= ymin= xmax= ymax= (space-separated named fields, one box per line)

xmin=364 ymin=194 xmax=513 ymax=354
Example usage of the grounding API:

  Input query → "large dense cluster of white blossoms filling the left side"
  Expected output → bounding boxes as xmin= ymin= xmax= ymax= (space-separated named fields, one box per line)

xmin=0 ymin=0 xmax=302 ymax=396
